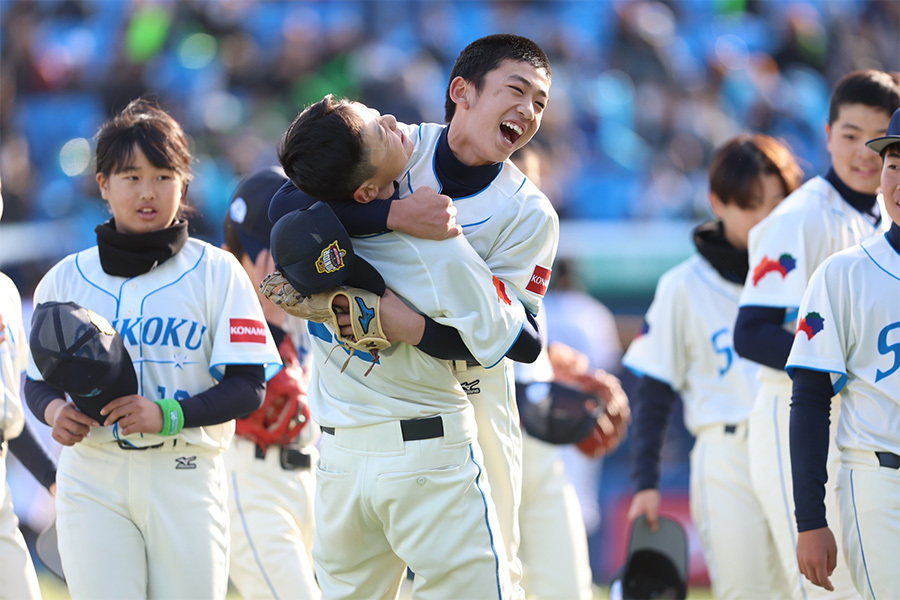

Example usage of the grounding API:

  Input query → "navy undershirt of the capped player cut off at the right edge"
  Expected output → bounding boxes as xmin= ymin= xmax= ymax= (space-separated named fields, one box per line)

xmin=790 ymin=223 xmax=900 ymax=531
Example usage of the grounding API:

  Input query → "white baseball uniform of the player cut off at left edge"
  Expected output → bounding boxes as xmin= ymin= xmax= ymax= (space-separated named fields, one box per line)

xmin=0 ymin=273 xmax=41 ymax=599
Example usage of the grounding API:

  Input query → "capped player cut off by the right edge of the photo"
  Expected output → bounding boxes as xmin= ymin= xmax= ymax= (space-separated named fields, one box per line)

xmin=787 ymin=110 xmax=900 ymax=599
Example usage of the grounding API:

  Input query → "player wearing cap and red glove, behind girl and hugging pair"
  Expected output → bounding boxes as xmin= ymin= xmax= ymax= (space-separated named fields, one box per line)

xmin=223 ymin=167 xmax=321 ymax=600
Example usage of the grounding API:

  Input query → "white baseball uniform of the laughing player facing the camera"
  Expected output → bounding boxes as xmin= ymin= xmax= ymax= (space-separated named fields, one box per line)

xmin=400 ymin=123 xmax=559 ymax=588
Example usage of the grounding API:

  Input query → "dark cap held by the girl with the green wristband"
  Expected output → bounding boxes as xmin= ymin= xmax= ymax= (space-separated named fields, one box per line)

xmin=28 ymin=302 xmax=138 ymax=423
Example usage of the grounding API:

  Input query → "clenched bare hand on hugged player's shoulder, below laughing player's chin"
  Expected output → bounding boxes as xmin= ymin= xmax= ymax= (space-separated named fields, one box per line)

xmin=387 ymin=187 xmax=462 ymax=240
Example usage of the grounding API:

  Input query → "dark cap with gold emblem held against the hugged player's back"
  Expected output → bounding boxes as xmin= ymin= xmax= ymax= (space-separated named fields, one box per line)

xmin=271 ymin=201 xmax=385 ymax=296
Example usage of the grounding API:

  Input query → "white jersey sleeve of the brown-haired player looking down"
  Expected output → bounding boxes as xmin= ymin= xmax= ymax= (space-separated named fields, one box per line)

xmin=622 ymin=271 xmax=688 ymax=391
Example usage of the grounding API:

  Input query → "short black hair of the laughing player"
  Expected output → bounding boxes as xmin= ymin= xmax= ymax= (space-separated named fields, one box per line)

xmin=444 ymin=33 xmax=553 ymax=123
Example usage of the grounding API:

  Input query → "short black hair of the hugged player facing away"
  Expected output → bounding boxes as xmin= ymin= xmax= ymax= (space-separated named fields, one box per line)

xmin=278 ymin=94 xmax=375 ymax=202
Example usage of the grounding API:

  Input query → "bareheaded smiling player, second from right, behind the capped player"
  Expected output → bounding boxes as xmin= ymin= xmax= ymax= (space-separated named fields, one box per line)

xmin=734 ymin=70 xmax=900 ymax=599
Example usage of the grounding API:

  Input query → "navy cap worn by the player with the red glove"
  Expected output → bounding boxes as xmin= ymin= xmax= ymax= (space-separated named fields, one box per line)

xmin=225 ymin=167 xmax=288 ymax=260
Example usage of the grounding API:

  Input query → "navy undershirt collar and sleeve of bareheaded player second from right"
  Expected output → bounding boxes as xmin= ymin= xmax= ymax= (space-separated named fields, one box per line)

xmin=734 ymin=167 xmax=881 ymax=371
